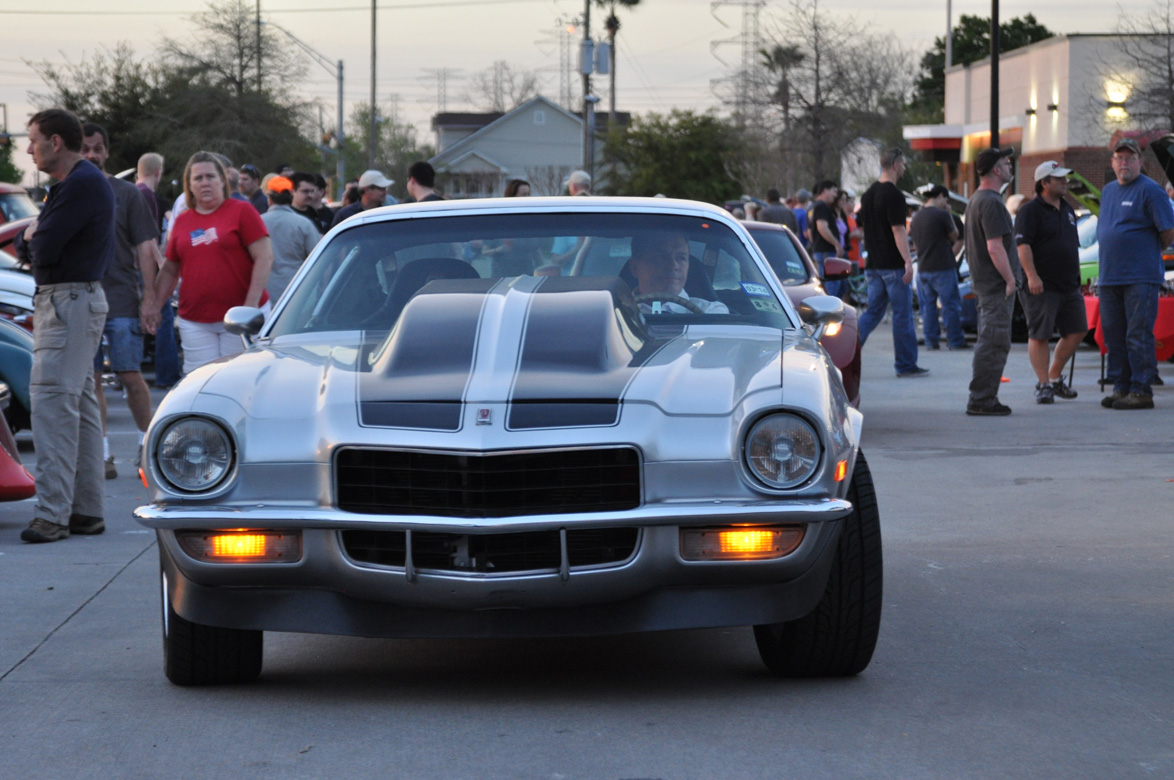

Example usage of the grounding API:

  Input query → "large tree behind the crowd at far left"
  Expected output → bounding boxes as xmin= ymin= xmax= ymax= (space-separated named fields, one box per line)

xmin=32 ymin=0 xmax=322 ymax=177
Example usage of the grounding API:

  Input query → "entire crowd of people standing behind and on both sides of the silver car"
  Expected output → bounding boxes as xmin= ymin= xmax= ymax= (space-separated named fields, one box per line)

xmin=15 ymin=109 xmax=1174 ymax=543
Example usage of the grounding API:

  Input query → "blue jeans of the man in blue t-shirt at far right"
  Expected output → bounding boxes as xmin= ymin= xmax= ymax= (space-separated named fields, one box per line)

xmin=1100 ymin=283 xmax=1159 ymax=396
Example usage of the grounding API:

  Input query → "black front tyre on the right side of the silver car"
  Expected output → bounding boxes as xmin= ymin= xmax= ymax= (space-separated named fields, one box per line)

xmin=754 ymin=452 xmax=884 ymax=677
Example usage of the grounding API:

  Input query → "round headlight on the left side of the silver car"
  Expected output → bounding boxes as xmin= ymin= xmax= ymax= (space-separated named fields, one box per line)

xmin=155 ymin=417 xmax=232 ymax=492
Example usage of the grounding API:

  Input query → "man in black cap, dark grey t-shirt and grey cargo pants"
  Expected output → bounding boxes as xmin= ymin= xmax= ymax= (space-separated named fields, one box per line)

xmin=965 ymin=148 xmax=1019 ymax=417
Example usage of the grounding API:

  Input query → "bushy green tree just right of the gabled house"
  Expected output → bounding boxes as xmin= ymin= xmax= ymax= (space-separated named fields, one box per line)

xmin=603 ymin=109 xmax=738 ymax=203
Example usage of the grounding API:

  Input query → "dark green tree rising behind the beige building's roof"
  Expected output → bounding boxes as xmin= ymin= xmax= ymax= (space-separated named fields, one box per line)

xmin=912 ymin=14 xmax=1055 ymax=122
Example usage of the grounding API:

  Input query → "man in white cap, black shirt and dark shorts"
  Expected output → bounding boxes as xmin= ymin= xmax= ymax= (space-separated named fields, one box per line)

xmin=1016 ymin=160 xmax=1088 ymax=404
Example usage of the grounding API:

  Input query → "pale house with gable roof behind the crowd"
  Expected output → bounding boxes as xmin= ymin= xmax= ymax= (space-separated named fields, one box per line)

xmin=429 ymin=95 xmax=628 ymax=199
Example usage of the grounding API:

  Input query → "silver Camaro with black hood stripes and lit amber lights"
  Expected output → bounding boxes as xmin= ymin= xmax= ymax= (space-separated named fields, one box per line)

xmin=135 ymin=197 xmax=882 ymax=685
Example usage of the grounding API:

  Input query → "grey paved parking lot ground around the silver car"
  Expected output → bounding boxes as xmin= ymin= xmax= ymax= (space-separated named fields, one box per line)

xmin=0 ymin=324 xmax=1174 ymax=780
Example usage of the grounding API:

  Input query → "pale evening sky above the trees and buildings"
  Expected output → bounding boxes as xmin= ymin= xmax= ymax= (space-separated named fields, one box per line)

xmin=0 ymin=0 xmax=1155 ymax=184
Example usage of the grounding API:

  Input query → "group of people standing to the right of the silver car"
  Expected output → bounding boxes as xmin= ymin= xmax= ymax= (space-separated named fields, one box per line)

xmin=734 ymin=137 xmax=1174 ymax=416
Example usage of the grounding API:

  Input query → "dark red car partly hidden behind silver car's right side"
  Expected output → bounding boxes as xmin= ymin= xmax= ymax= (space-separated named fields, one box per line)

xmin=743 ymin=216 xmax=861 ymax=408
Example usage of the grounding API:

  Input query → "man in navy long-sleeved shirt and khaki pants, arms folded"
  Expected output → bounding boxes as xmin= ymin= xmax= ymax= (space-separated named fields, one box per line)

xmin=15 ymin=108 xmax=115 ymax=543
